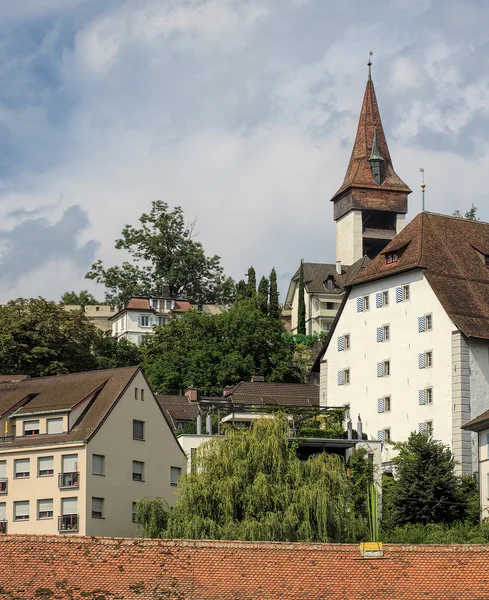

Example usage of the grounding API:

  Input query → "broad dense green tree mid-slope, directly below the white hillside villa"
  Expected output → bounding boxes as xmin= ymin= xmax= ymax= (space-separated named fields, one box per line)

xmin=140 ymin=298 xmax=298 ymax=395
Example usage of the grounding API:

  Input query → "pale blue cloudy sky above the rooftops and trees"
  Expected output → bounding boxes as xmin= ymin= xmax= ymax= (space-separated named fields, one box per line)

xmin=0 ymin=0 xmax=489 ymax=302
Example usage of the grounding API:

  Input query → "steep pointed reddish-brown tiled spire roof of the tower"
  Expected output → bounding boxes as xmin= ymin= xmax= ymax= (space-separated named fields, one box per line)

xmin=331 ymin=76 xmax=411 ymax=201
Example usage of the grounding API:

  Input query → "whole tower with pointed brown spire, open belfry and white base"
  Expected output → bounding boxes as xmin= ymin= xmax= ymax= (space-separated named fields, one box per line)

xmin=331 ymin=61 xmax=411 ymax=265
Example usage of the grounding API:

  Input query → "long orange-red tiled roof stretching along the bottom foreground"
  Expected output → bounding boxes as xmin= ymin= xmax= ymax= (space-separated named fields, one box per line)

xmin=0 ymin=536 xmax=489 ymax=600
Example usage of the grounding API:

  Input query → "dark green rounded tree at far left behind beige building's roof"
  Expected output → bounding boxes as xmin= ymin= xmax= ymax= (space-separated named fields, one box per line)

xmin=0 ymin=298 xmax=97 ymax=377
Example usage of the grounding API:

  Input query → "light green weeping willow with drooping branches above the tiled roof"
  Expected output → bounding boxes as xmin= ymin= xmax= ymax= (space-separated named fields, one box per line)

xmin=137 ymin=417 xmax=358 ymax=542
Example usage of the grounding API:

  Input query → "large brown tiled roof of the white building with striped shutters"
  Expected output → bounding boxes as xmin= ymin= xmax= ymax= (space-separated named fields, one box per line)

xmin=352 ymin=212 xmax=489 ymax=339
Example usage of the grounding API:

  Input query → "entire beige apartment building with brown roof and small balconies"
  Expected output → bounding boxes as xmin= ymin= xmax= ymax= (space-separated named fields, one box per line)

xmin=0 ymin=367 xmax=186 ymax=537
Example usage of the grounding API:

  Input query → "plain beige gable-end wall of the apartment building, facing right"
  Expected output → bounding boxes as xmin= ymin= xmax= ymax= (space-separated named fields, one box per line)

xmin=86 ymin=373 xmax=186 ymax=537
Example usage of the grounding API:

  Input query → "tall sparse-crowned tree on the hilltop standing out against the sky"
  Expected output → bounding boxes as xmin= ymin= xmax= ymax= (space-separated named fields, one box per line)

xmin=86 ymin=201 xmax=235 ymax=305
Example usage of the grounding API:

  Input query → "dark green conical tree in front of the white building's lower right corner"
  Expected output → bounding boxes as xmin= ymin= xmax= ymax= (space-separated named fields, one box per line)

xmin=392 ymin=433 xmax=467 ymax=525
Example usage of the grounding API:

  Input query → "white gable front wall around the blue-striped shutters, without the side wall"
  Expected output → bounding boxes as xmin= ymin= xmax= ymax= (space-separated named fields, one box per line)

xmin=320 ymin=271 xmax=455 ymax=460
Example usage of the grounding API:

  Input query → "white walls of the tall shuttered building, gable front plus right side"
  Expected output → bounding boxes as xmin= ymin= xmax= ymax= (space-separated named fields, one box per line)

xmin=320 ymin=270 xmax=489 ymax=473
